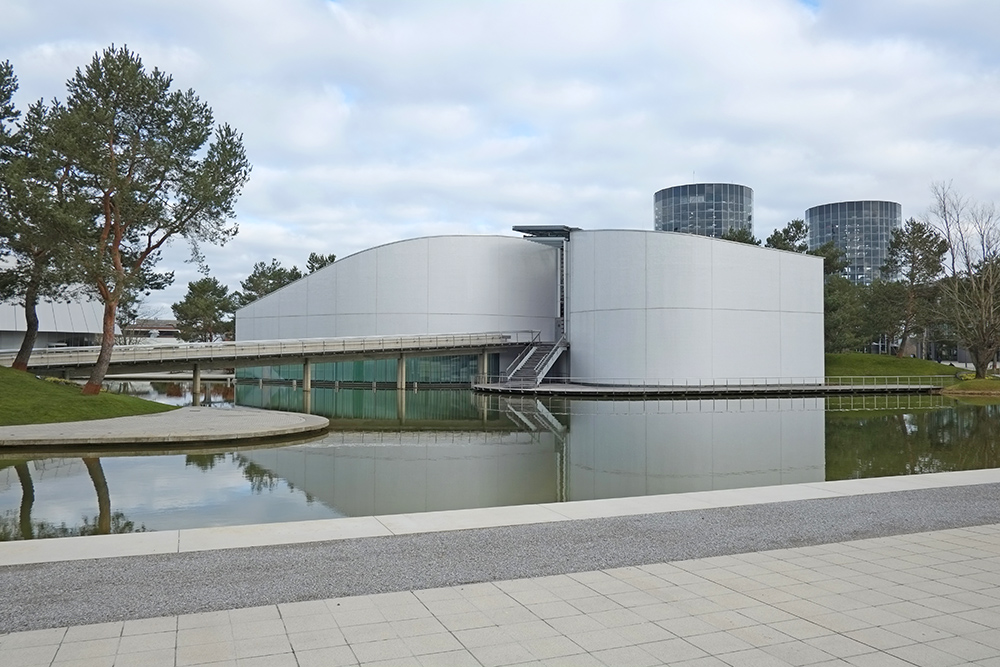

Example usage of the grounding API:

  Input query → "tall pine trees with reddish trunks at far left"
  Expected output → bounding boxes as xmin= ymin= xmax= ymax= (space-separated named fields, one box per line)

xmin=0 ymin=46 xmax=250 ymax=394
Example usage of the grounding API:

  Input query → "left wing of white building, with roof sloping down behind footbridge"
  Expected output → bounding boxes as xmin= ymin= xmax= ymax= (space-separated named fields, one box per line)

xmin=236 ymin=236 xmax=559 ymax=340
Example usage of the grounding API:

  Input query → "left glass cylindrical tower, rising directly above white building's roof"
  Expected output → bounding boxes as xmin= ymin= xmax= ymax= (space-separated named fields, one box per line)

xmin=653 ymin=183 xmax=753 ymax=237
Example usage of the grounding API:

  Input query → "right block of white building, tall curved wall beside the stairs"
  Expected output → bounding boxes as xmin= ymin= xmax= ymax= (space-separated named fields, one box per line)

xmin=567 ymin=230 xmax=823 ymax=384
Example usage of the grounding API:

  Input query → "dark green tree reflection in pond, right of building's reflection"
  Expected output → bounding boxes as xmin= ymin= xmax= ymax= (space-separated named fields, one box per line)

xmin=826 ymin=403 xmax=1000 ymax=480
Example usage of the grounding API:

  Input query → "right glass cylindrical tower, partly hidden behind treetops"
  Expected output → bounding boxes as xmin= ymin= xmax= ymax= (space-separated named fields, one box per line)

xmin=806 ymin=201 xmax=903 ymax=285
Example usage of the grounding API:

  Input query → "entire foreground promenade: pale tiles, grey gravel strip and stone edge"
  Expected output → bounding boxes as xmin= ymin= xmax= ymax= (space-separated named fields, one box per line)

xmin=0 ymin=470 xmax=1000 ymax=667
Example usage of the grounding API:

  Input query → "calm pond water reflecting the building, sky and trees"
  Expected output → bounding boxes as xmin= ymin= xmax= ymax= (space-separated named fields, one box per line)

xmin=0 ymin=386 xmax=1000 ymax=540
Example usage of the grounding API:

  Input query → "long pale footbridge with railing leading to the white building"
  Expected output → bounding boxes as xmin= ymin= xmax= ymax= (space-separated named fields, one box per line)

xmin=0 ymin=330 xmax=538 ymax=368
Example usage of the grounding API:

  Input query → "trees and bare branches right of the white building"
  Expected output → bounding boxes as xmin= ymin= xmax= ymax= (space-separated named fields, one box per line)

xmin=724 ymin=183 xmax=1000 ymax=377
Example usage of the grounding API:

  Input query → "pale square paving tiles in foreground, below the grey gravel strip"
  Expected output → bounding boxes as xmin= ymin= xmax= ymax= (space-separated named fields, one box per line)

xmin=0 ymin=526 xmax=1000 ymax=667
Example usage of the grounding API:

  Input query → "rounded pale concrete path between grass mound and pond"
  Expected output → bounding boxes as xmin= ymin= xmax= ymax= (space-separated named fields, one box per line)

xmin=0 ymin=407 xmax=330 ymax=447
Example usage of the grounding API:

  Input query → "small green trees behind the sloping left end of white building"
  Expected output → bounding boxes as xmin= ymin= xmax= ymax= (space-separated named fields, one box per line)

xmin=171 ymin=252 xmax=336 ymax=342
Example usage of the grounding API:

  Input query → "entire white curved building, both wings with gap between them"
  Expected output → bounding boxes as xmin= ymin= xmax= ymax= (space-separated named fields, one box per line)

xmin=236 ymin=227 xmax=824 ymax=383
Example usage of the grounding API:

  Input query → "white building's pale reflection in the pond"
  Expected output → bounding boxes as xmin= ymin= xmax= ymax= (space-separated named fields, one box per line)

xmin=241 ymin=387 xmax=825 ymax=516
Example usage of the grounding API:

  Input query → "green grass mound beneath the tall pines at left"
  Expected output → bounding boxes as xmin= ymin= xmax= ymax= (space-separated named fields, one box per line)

xmin=0 ymin=366 xmax=174 ymax=426
